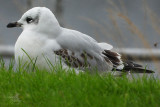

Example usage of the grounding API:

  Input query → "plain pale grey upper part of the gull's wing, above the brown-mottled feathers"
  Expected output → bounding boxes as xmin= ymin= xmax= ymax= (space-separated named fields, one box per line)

xmin=56 ymin=28 xmax=104 ymax=60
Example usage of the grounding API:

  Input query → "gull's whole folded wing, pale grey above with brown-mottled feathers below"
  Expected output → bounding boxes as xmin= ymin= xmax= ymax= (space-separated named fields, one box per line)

xmin=54 ymin=28 xmax=121 ymax=71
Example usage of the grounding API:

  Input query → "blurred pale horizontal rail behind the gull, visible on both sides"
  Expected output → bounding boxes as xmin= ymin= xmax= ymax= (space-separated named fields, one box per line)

xmin=0 ymin=45 xmax=160 ymax=60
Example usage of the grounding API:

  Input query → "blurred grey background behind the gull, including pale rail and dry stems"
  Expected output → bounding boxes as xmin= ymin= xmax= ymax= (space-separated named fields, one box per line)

xmin=0 ymin=0 xmax=160 ymax=74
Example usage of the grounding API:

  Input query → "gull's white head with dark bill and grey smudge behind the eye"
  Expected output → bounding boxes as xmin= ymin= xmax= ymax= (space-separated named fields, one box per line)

xmin=7 ymin=7 xmax=60 ymax=35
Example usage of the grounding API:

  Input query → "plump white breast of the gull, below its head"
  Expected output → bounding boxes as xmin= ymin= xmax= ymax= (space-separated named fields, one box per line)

xmin=15 ymin=31 xmax=58 ymax=68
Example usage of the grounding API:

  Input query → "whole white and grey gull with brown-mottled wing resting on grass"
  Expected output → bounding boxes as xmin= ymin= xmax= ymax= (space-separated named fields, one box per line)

xmin=7 ymin=7 xmax=153 ymax=73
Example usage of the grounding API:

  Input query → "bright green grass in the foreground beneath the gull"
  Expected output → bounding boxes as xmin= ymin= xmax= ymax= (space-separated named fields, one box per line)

xmin=0 ymin=61 xmax=160 ymax=107
